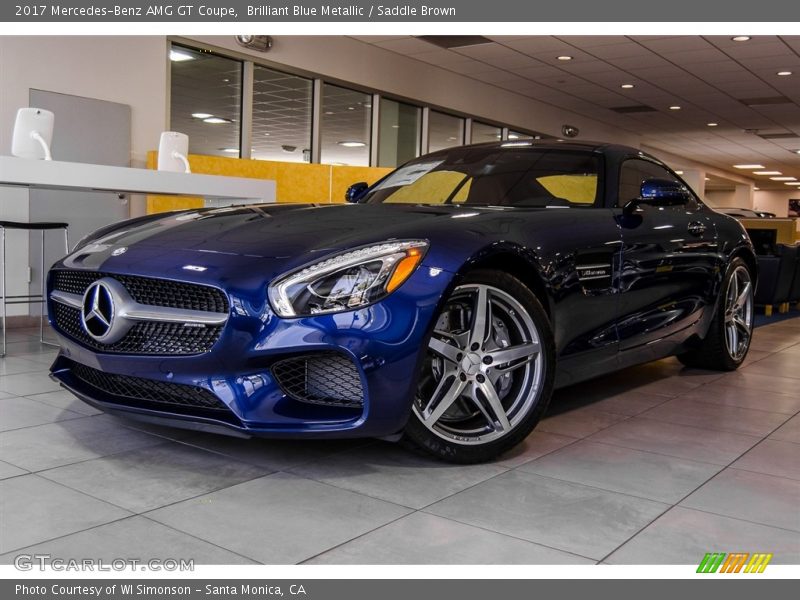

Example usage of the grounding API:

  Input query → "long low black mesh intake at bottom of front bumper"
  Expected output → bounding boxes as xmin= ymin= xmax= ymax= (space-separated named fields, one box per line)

xmin=69 ymin=361 xmax=235 ymax=419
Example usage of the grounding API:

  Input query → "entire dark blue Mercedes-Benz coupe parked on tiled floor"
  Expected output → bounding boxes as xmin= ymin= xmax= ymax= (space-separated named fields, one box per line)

xmin=48 ymin=141 xmax=756 ymax=462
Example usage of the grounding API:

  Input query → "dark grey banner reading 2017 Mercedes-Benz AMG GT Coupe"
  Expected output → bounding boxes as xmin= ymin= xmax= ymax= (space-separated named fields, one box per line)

xmin=0 ymin=0 xmax=800 ymax=22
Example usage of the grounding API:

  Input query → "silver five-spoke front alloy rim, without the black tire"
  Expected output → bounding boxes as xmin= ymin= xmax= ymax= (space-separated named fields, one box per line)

xmin=413 ymin=284 xmax=544 ymax=445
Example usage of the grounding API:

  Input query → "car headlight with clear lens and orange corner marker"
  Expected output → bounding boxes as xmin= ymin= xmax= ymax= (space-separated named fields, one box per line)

xmin=268 ymin=240 xmax=428 ymax=317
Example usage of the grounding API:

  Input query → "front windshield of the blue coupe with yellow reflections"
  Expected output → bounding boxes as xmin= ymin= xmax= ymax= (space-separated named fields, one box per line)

xmin=363 ymin=146 xmax=600 ymax=207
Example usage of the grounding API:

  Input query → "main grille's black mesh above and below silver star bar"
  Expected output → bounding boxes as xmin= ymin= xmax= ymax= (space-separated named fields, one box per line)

xmin=51 ymin=270 xmax=228 ymax=355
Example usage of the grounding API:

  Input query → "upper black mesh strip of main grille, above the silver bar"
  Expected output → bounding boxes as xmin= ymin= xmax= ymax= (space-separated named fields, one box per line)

xmin=53 ymin=270 xmax=229 ymax=313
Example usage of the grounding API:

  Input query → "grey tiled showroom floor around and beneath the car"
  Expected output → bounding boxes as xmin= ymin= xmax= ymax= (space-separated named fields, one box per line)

xmin=0 ymin=318 xmax=800 ymax=565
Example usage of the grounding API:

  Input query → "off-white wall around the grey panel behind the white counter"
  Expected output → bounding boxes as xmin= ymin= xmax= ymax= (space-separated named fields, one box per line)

xmin=0 ymin=36 xmax=168 ymax=315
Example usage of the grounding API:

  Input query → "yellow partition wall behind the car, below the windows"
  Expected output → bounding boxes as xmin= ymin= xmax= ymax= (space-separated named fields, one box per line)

xmin=147 ymin=150 xmax=391 ymax=214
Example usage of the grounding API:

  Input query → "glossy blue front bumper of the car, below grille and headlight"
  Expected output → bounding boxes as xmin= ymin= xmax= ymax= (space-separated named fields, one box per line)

xmin=50 ymin=265 xmax=452 ymax=437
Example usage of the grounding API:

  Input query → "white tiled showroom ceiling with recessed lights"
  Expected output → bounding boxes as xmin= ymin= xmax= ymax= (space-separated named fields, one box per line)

xmin=355 ymin=36 xmax=800 ymax=190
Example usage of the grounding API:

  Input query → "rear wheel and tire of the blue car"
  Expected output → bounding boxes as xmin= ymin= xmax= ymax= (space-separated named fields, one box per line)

xmin=678 ymin=258 xmax=755 ymax=371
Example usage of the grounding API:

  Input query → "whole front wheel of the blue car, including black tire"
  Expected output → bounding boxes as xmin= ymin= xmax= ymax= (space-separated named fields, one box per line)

xmin=405 ymin=270 xmax=555 ymax=464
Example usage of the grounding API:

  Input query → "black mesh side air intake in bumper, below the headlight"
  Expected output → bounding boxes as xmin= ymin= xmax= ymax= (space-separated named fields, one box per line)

xmin=272 ymin=352 xmax=364 ymax=408
